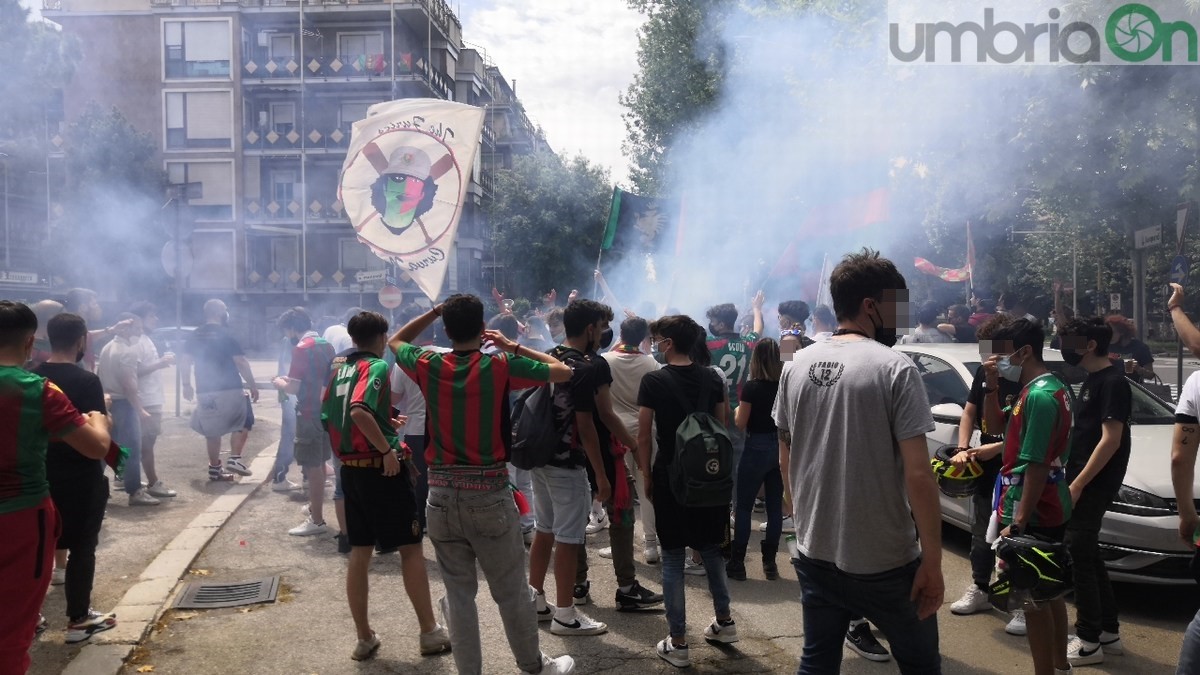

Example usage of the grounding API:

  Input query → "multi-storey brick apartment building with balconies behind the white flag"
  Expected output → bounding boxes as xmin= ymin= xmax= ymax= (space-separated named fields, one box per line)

xmin=36 ymin=0 xmax=548 ymax=333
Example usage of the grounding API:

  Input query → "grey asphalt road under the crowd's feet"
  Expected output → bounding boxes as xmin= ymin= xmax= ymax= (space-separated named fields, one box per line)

xmin=23 ymin=360 xmax=1200 ymax=675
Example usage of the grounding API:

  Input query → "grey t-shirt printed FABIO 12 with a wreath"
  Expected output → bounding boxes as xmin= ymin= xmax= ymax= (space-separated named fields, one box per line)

xmin=772 ymin=338 xmax=934 ymax=574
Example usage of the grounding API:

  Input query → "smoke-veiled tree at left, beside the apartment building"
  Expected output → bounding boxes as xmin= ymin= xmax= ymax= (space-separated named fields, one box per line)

xmin=55 ymin=104 xmax=167 ymax=298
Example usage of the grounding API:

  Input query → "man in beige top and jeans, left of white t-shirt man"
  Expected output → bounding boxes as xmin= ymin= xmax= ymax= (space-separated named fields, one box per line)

xmin=96 ymin=313 xmax=162 ymax=506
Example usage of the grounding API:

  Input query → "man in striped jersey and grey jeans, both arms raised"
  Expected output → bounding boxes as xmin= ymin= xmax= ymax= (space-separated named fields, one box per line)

xmin=389 ymin=295 xmax=575 ymax=675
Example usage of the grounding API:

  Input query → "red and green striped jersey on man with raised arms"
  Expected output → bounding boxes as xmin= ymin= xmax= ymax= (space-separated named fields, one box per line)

xmin=396 ymin=344 xmax=550 ymax=466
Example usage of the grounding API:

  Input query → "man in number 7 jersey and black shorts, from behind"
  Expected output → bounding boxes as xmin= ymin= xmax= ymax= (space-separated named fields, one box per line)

xmin=321 ymin=312 xmax=450 ymax=661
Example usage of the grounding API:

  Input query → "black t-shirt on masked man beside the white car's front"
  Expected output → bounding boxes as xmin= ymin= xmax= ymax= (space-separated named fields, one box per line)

xmin=1067 ymin=366 xmax=1133 ymax=491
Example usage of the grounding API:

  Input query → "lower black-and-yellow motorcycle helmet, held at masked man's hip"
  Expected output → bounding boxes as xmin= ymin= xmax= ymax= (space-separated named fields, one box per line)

xmin=988 ymin=534 xmax=1073 ymax=611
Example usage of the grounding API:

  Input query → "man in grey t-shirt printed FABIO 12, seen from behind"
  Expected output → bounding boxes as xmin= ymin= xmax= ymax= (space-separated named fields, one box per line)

xmin=772 ymin=249 xmax=944 ymax=673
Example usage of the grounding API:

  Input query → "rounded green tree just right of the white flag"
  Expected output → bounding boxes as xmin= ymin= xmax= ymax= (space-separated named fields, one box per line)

xmin=488 ymin=153 xmax=612 ymax=299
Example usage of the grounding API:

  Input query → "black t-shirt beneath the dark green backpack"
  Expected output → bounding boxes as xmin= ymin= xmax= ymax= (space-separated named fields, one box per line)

xmin=637 ymin=364 xmax=725 ymax=468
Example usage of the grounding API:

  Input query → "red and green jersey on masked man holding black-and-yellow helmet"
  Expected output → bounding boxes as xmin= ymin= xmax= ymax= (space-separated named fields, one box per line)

xmin=1000 ymin=374 xmax=1072 ymax=527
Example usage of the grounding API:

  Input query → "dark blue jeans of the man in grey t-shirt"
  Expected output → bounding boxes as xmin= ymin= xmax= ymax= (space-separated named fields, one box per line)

xmin=792 ymin=556 xmax=942 ymax=675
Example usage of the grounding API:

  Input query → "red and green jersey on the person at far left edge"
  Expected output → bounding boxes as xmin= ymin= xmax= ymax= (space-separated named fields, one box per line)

xmin=0 ymin=365 xmax=86 ymax=513
